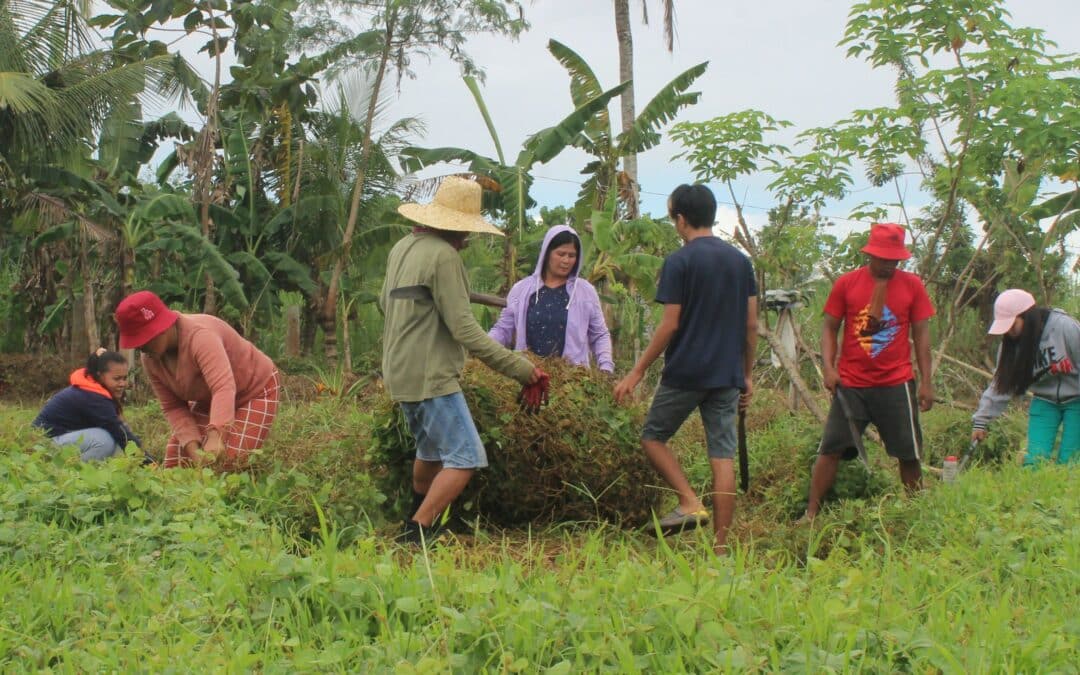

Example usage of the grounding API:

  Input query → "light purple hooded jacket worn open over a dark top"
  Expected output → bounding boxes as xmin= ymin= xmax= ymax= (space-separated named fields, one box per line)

xmin=488 ymin=225 xmax=615 ymax=373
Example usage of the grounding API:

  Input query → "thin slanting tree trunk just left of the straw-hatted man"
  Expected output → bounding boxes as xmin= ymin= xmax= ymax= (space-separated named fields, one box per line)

xmin=319 ymin=13 xmax=397 ymax=362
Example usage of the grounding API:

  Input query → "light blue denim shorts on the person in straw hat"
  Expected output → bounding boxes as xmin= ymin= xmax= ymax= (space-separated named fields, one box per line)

xmin=402 ymin=391 xmax=487 ymax=469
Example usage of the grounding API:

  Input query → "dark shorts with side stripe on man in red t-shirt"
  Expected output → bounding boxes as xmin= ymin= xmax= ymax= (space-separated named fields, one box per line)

xmin=818 ymin=380 xmax=922 ymax=461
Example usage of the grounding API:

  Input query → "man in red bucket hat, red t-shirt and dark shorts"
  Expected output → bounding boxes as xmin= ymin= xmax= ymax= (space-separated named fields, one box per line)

xmin=806 ymin=222 xmax=934 ymax=519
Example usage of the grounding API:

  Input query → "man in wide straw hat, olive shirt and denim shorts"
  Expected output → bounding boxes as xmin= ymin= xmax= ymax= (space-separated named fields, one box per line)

xmin=380 ymin=176 xmax=548 ymax=544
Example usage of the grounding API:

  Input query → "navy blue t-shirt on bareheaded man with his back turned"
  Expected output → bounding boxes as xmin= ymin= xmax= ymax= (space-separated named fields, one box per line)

xmin=657 ymin=237 xmax=757 ymax=390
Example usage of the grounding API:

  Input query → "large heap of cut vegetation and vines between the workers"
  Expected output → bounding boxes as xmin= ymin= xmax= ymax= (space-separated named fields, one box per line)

xmin=369 ymin=359 xmax=663 ymax=525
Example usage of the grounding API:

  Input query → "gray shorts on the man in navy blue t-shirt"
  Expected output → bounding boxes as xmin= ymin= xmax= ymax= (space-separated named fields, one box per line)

xmin=642 ymin=384 xmax=740 ymax=459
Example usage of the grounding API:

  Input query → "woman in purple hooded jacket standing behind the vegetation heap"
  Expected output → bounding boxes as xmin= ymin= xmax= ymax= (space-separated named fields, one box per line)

xmin=488 ymin=225 xmax=615 ymax=373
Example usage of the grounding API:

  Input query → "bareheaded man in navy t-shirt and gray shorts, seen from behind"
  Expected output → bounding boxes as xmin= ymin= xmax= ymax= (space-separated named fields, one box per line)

xmin=615 ymin=185 xmax=757 ymax=553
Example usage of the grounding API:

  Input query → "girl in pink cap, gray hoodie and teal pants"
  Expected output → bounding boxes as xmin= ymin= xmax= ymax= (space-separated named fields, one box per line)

xmin=971 ymin=288 xmax=1080 ymax=465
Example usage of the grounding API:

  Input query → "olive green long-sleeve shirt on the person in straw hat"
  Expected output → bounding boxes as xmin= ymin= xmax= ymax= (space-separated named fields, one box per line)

xmin=379 ymin=232 xmax=534 ymax=402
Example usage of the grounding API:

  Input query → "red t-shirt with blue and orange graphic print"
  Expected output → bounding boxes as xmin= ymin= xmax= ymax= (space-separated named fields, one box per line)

xmin=825 ymin=267 xmax=934 ymax=387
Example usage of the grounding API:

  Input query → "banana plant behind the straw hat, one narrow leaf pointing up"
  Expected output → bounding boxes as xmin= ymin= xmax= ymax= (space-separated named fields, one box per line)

xmin=402 ymin=77 xmax=626 ymax=291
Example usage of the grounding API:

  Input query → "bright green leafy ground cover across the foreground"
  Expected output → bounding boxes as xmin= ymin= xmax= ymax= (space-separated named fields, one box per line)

xmin=0 ymin=399 xmax=1080 ymax=673
